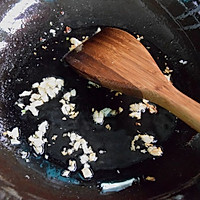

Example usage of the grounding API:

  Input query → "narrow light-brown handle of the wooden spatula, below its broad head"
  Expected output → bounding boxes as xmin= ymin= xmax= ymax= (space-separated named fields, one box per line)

xmin=152 ymin=86 xmax=200 ymax=132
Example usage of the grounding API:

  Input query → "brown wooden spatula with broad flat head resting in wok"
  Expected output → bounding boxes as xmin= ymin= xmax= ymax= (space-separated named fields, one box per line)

xmin=66 ymin=28 xmax=200 ymax=132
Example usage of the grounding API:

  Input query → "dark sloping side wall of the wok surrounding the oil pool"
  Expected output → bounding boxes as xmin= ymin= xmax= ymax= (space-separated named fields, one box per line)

xmin=0 ymin=1 xmax=200 ymax=199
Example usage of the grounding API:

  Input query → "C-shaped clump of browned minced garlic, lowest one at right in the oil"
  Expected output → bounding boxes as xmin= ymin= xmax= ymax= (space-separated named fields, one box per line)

xmin=131 ymin=134 xmax=163 ymax=156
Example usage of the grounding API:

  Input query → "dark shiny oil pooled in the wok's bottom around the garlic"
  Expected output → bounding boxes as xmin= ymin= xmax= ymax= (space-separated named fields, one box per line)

xmin=1 ymin=28 xmax=175 ymax=186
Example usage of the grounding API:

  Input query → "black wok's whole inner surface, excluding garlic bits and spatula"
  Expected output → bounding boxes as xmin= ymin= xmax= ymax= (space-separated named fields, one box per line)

xmin=0 ymin=1 xmax=200 ymax=199
